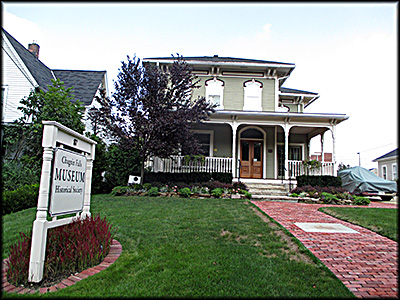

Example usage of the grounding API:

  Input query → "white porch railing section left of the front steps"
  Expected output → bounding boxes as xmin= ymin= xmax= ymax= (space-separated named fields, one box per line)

xmin=147 ymin=155 xmax=232 ymax=173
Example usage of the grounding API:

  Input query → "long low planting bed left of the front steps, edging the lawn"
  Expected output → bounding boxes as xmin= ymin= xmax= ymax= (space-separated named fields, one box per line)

xmin=111 ymin=181 xmax=251 ymax=199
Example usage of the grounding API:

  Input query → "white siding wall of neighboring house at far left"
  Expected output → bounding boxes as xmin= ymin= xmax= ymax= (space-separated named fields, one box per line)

xmin=1 ymin=43 xmax=35 ymax=122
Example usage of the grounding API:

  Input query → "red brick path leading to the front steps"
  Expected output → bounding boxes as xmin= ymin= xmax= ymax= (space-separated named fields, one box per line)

xmin=252 ymin=201 xmax=398 ymax=298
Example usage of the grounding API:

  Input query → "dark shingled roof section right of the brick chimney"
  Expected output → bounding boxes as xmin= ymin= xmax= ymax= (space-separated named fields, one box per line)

xmin=53 ymin=70 xmax=106 ymax=105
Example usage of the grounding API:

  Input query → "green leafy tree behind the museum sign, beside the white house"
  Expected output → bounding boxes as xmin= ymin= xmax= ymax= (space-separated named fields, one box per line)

xmin=3 ymin=79 xmax=85 ymax=190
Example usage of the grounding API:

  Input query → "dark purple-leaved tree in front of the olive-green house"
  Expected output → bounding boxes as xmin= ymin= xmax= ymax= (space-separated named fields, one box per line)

xmin=91 ymin=55 xmax=214 ymax=182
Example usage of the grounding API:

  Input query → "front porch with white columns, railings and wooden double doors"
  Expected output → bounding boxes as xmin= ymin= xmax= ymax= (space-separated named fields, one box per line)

xmin=147 ymin=111 xmax=348 ymax=181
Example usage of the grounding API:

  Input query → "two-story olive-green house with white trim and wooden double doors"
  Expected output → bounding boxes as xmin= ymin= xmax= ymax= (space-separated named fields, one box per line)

xmin=143 ymin=55 xmax=348 ymax=182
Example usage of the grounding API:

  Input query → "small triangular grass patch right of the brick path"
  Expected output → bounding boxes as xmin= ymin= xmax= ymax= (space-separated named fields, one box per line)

xmin=319 ymin=207 xmax=398 ymax=242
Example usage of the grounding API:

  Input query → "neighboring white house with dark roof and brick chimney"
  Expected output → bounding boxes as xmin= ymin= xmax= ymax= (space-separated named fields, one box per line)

xmin=1 ymin=29 xmax=108 ymax=131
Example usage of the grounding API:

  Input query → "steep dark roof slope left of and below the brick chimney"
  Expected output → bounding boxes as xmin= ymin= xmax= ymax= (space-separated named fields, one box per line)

xmin=2 ymin=29 xmax=54 ymax=90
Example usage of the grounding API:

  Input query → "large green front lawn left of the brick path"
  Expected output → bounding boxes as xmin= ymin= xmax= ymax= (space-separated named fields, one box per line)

xmin=3 ymin=195 xmax=354 ymax=298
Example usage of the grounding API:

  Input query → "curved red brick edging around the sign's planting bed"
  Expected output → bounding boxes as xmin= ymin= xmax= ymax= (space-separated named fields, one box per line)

xmin=1 ymin=240 xmax=122 ymax=294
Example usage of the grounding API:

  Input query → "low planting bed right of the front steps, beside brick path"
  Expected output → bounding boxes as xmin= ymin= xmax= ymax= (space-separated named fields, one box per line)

xmin=290 ymin=186 xmax=371 ymax=205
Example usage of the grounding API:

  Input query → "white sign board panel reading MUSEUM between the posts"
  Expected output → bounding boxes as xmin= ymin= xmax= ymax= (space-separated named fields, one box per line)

xmin=49 ymin=148 xmax=86 ymax=217
